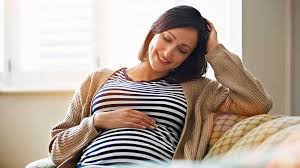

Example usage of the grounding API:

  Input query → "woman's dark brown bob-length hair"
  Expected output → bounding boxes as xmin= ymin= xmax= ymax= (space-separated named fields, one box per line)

xmin=139 ymin=5 xmax=208 ymax=82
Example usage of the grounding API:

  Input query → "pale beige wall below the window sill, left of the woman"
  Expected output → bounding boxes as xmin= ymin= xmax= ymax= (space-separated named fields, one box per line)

xmin=0 ymin=93 xmax=73 ymax=168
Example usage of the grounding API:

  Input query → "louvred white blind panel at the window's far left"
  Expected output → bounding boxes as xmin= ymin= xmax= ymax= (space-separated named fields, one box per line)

xmin=19 ymin=0 xmax=93 ymax=71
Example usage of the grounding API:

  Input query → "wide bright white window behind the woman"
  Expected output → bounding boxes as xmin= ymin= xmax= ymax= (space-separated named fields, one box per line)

xmin=0 ymin=0 xmax=242 ymax=91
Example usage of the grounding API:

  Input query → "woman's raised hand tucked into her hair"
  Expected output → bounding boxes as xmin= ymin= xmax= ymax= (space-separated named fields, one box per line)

xmin=206 ymin=20 xmax=219 ymax=53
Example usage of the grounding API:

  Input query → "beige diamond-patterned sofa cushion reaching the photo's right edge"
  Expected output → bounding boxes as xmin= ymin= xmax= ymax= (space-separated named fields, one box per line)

xmin=205 ymin=114 xmax=300 ymax=159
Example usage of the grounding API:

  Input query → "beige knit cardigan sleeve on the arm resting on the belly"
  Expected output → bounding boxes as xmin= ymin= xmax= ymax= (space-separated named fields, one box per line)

xmin=49 ymin=74 xmax=99 ymax=166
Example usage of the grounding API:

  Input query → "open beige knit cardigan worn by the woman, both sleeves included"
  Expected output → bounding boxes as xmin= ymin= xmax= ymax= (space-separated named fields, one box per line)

xmin=49 ymin=44 xmax=272 ymax=168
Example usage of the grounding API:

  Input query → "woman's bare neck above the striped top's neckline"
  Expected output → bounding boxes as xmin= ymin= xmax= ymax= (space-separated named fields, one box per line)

xmin=127 ymin=62 xmax=167 ymax=81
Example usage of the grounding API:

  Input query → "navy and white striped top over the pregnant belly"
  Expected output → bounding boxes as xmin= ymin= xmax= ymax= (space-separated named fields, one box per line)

xmin=77 ymin=68 xmax=187 ymax=167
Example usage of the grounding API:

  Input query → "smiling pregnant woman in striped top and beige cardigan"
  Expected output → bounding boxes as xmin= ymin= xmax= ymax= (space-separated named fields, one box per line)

xmin=49 ymin=6 xmax=272 ymax=167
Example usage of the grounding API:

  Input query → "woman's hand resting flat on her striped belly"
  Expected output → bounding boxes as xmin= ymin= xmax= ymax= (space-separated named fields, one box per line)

xmin=94 ymin=109 xmax=156 ymax=130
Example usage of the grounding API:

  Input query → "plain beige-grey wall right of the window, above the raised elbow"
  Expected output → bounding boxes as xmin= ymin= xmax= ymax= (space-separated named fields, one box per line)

xmin=242 ymin=0 xmax=292 ymax=115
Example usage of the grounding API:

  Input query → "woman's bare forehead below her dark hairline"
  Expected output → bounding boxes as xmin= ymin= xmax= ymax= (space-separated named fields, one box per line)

xmin=164 ymin=27 xmax=198 ymax=47
